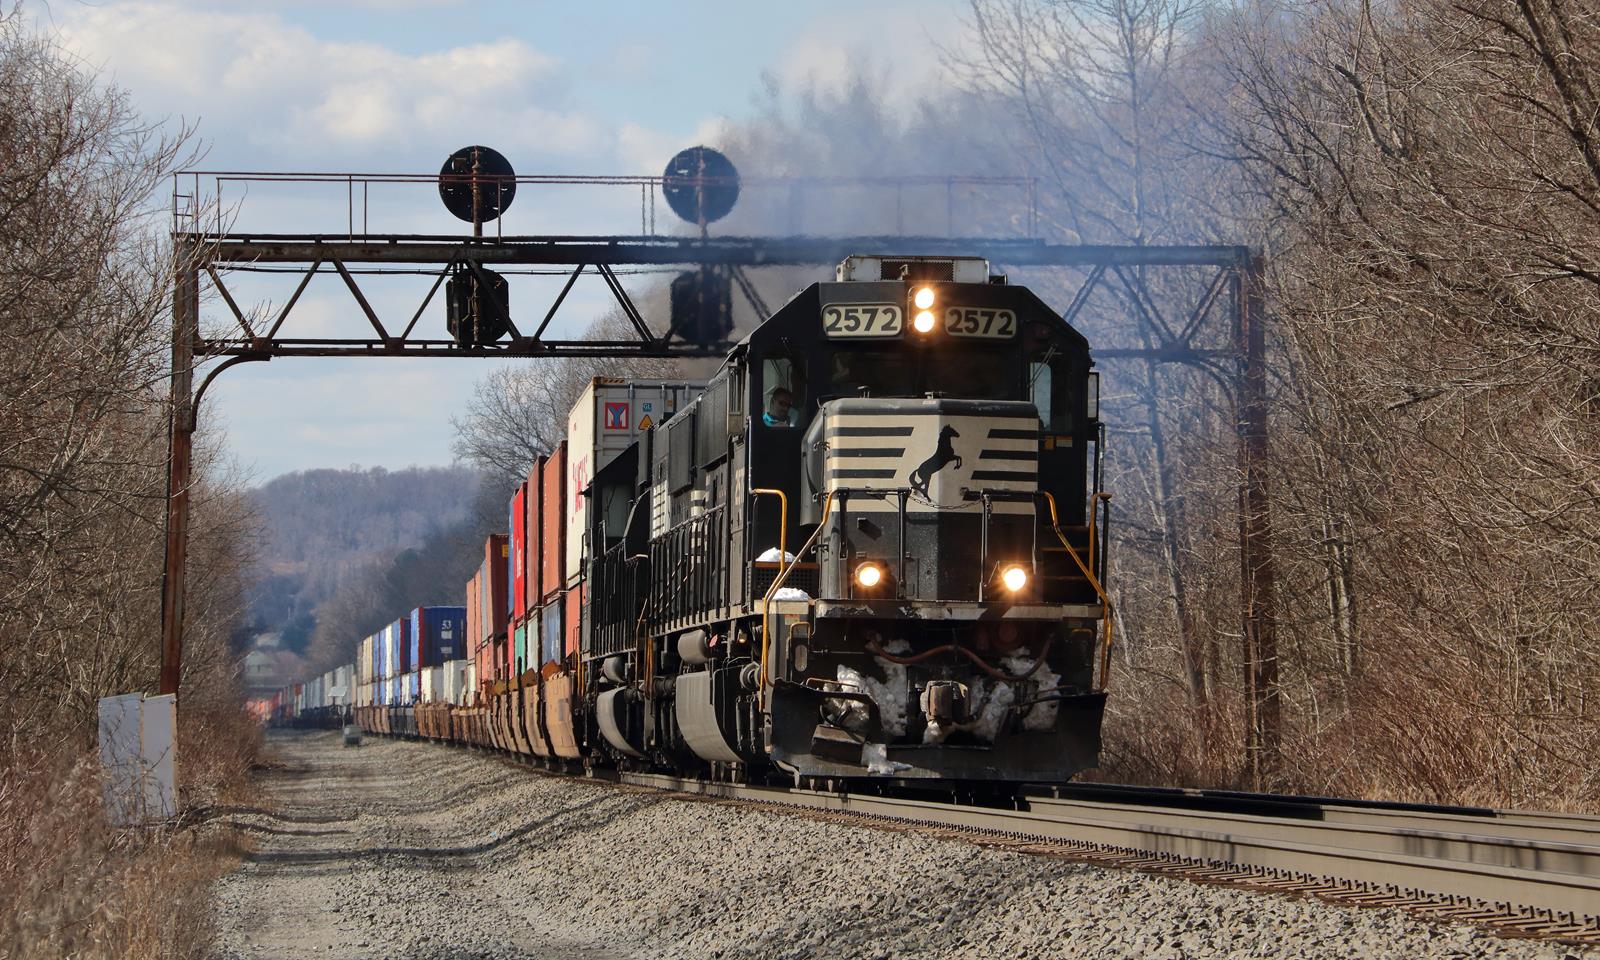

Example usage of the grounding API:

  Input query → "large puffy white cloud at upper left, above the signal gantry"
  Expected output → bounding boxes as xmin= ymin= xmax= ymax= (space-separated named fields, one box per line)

xmin=59 ymin=2 xmax=606 ymax=165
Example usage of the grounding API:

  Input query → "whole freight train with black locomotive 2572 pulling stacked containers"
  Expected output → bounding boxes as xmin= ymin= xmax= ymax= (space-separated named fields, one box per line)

xmin=265 ymin=256 xmax=1112 ymax=786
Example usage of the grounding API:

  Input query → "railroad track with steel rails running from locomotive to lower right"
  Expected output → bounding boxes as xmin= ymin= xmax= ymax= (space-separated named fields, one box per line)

xmin=616 ymin=773 xmax=1600 ymax=946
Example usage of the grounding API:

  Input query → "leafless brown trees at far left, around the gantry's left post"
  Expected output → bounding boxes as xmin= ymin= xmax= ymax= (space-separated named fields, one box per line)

xmin=0 ymin=14 xmax=251 ymax=744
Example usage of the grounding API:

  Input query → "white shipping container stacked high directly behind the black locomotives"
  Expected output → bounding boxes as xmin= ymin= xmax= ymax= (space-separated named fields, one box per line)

xmin=569 ymin=378 xmax=706 ymax=589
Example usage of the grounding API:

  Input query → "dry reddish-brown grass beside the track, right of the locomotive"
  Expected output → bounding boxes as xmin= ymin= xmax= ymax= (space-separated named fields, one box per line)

xmin=1085 ymin=651 xmax=1600 ymax=813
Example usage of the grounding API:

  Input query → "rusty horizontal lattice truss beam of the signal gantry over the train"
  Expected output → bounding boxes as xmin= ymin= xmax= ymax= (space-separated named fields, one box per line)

xmin=190 ymin=235 xmax=1250 ymax=366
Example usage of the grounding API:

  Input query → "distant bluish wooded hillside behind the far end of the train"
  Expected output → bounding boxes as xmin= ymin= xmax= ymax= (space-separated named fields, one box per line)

xmin=250 ymin=467 xmax=478 ymax=651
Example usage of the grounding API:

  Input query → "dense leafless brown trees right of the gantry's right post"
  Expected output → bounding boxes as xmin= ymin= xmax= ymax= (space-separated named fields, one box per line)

xmin=1216 ymin=0 xmax=1600 ymax=803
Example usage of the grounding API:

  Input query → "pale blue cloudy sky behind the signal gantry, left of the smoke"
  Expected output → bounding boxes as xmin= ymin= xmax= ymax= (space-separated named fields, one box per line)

xmin=22 ymin=0 xmax=963 ymax=482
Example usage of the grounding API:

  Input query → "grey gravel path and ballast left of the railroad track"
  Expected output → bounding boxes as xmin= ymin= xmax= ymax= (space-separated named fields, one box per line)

xmin=214 ymin=733 xmax=1600 ymax=960
